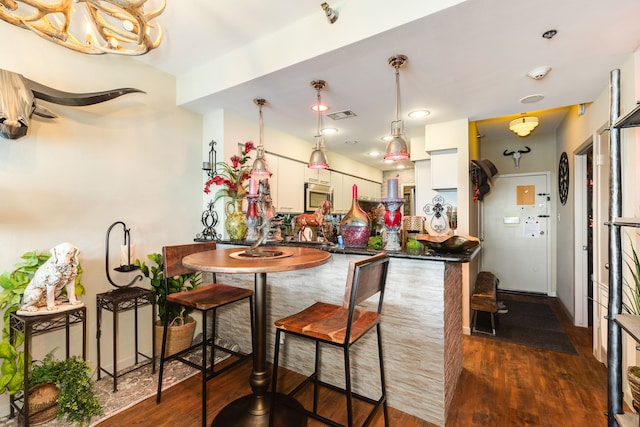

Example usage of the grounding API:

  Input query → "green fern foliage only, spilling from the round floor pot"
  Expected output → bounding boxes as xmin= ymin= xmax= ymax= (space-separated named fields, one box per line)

xmin=29 ymin=350 xmax=102 ymax=426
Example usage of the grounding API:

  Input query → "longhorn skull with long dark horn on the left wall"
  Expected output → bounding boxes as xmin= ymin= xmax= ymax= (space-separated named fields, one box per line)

xmin=0 ymin=69 xmax=144 ymax=139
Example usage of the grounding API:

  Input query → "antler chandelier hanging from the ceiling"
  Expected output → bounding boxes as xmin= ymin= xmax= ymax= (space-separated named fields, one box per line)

xmin=0 ymin=0 xmax=166 ymax=55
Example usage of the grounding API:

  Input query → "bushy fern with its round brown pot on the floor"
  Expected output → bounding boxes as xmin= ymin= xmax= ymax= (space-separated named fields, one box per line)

xmin=29 ymin=350 xmax=102 ymax=426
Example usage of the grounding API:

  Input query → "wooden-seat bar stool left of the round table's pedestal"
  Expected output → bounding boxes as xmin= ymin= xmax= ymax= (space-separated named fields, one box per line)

xmin=156 ymin=242 xmax=254 ymax=427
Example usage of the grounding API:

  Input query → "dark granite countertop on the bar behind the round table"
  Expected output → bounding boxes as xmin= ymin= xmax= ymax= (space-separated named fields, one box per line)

xmin=212 ymin=240 xmax=481 ymax=263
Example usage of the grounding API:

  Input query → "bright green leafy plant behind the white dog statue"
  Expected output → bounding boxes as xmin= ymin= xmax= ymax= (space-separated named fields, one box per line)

xmin=0 ymin=251 xmax=84 ymax=395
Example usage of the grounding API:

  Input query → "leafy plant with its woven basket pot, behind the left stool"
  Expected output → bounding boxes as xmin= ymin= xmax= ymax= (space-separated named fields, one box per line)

xmin=135 ymin=253 xmax=202 ymax=356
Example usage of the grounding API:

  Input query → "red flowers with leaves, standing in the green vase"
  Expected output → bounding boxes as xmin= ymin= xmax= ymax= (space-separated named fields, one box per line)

xmin=204 ymin=141 xmax=255 ymax=202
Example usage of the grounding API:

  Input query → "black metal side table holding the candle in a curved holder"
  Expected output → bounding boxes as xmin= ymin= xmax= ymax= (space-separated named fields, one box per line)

xmin=96 ymin=286 xmax=156 ymax=392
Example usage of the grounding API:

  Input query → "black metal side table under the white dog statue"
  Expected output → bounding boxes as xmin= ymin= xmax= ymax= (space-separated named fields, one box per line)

xmin=9 ymin=305 xmax=87 ymax=426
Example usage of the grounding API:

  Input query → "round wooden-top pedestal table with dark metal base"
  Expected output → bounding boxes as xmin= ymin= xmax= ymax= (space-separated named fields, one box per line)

xmin=182 ymin=246 xmax=331 ymax=427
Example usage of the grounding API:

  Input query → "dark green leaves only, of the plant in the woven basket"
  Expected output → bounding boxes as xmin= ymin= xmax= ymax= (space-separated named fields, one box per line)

xmin=135 ymin=253 xmax=202 ymax=324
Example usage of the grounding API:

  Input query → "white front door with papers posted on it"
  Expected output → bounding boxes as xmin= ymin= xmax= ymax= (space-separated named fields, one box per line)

xmin=480 ymin=173 xmax=552 ymax=294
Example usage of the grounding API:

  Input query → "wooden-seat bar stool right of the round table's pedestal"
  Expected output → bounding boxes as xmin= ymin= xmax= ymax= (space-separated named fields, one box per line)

xmin=272 ymin=252 xmax=389 ymax=427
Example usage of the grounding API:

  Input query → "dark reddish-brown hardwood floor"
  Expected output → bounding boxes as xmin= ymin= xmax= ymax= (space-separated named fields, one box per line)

xmin=99 ymin=296 xmax=607 ymax=427
